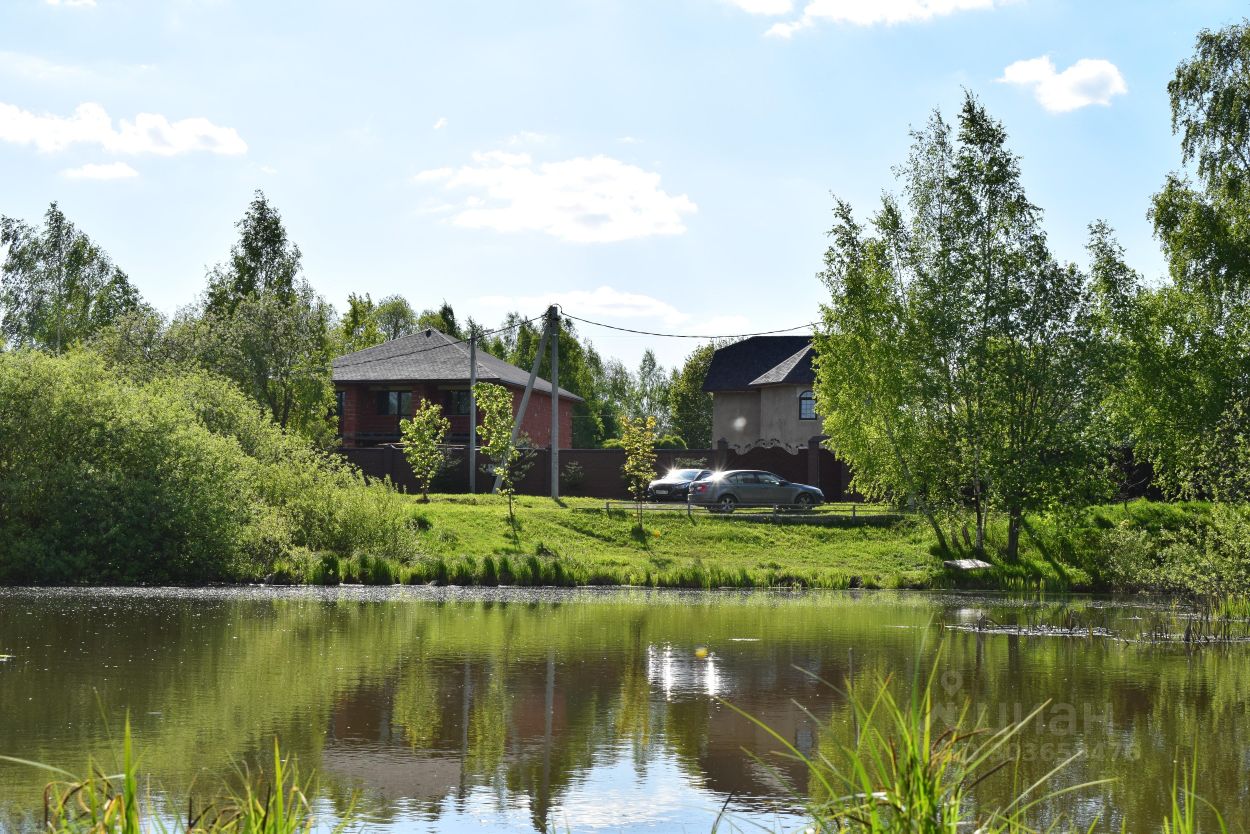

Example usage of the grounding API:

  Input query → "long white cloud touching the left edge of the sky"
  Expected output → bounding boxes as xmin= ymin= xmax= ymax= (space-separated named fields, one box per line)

xmin=0 ymin=101 xmax=248 ymax=156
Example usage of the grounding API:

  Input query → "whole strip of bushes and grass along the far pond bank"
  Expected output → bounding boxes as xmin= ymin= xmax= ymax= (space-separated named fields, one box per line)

xmin=0 ymin=350 xmax=1250 ymax=598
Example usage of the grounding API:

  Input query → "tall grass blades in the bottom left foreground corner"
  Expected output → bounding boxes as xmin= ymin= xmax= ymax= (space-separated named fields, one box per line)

xmin=0 ymin=720 xmax=353 ymax=834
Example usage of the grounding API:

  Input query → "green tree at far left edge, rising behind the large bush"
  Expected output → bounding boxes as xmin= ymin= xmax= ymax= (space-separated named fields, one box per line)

xmin=0 ymin=203 xmax=146 ymax=353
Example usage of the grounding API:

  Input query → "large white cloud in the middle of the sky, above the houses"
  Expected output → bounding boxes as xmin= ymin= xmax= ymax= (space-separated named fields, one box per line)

xmin=414 ymin=150 xmax=698 ymax=243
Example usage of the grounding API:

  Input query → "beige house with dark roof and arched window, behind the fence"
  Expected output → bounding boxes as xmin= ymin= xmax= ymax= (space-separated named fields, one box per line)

xmin=703 ymin=336 xmax=824 ymax=453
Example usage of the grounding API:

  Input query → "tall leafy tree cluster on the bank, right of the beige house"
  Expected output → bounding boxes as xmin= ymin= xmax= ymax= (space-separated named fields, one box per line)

xmin=816 ymin=95 xmax=1108 ymax=558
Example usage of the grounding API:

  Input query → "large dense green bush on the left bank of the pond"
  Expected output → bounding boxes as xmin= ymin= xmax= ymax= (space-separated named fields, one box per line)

xmin=0 ymin=351 xmax=421 ymax=584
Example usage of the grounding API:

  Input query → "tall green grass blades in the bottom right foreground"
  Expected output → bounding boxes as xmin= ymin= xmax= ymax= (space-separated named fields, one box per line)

xmin=721 ymin=651 xmax=1226 ymax=834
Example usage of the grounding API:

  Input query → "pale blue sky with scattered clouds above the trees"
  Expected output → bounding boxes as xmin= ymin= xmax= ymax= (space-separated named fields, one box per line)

xmin=0 ymin=0 xmax=1245 ymax=364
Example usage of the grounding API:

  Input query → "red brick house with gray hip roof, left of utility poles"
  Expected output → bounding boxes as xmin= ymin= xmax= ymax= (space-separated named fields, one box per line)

xmin=331 ymin=329 xmax=581 ymax=449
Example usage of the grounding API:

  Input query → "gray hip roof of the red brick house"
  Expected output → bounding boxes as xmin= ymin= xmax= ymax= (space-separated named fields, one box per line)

xmin=331 ymin=328 xmax=581 ymax=401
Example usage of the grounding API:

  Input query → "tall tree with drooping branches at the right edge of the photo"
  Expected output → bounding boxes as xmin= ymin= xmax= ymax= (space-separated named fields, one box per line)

xmin=1119 ymin=21 xmax=1250 ymax=501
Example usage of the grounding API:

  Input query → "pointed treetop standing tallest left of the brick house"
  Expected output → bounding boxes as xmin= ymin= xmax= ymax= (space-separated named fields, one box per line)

xmin=204 ymin=189 xmax=303 ymax=315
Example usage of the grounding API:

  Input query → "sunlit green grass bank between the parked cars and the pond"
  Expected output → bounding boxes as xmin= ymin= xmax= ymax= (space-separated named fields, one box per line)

xmin=278 ymin=495 xmax=1225 ymax=591
